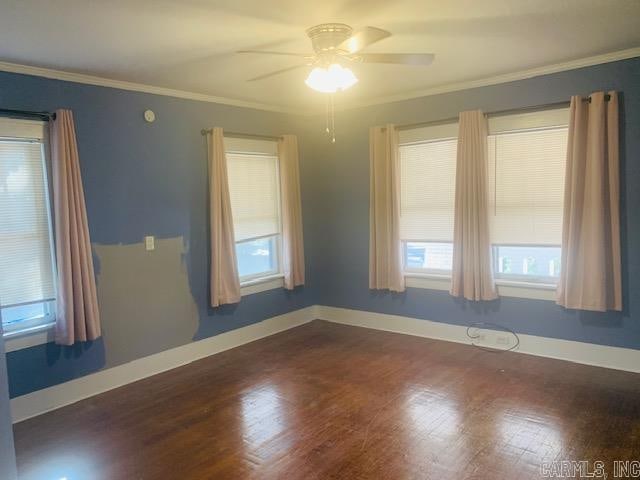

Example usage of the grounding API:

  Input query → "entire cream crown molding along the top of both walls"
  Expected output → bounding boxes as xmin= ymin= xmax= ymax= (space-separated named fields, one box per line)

xmin=0 ymin=47 xmax=640 ymax=116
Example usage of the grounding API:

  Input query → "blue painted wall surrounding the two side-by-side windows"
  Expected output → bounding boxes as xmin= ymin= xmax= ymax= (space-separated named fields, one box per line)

xmin=314 ymin=58 xmax=640 ymax=349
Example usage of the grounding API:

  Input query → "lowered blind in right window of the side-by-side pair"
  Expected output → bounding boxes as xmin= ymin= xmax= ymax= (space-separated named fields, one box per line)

xmin=488 ymin=109 xmax=568 ymax=245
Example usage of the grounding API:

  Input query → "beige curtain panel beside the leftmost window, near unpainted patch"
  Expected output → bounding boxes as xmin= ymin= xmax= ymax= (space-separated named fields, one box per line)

xmin=49 ymin=110 xmax=101 ymax=345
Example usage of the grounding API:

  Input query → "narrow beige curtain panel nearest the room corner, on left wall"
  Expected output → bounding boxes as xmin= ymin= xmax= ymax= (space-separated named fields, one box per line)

xmin=278 ymin=135 xmax=304 ymax=290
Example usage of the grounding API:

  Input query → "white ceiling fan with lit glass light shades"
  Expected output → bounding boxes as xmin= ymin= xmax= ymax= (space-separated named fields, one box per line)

xmin=237 ymin=23 xmax=434 ymax=93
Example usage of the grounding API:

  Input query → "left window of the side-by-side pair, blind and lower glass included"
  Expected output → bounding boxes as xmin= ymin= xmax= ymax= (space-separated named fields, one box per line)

xmin=399 ymin=124 xmax=458 ymax=275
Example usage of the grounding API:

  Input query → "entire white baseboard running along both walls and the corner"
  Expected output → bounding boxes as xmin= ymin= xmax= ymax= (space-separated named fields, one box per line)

xmin=11 ymin=305 xmax=640 ymax=423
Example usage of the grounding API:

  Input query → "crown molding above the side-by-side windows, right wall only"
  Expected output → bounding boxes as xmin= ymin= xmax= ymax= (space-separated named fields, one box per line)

xmin=336 ymin=47 xmax=640 ymax=110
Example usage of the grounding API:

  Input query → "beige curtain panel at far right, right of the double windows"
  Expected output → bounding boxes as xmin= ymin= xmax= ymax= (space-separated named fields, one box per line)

xmin=558 ymin=92 xmax=622 ymax=312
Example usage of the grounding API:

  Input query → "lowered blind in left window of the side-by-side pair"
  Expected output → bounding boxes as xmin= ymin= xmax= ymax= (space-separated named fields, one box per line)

xmin=400 ymin=131 xmax=457 ymax=242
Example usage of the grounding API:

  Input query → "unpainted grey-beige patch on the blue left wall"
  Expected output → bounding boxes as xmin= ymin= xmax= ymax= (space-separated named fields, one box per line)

xmin=93 ymin=237 xmax=199 ymax=366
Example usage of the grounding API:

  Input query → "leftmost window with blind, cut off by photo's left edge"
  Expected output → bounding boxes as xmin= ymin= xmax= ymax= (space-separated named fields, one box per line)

xmin=0 ymin=119 xmax=55 ymax=335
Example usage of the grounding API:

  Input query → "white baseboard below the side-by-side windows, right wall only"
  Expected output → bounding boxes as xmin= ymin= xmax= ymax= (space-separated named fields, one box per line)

xmin=317 ymin=305 xmax=640 ymax=372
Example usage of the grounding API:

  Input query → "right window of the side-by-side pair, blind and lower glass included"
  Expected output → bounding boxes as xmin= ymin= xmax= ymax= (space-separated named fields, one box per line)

xmin=488 ymin=109 xmax=569 ymax=283
